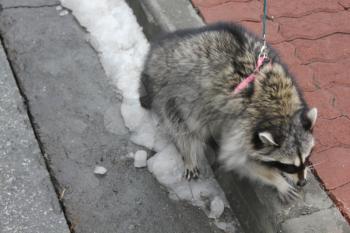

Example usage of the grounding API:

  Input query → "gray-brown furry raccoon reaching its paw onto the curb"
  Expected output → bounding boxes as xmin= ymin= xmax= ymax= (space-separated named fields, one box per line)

xmin=139 ymin=23 xmax=317 ymax=200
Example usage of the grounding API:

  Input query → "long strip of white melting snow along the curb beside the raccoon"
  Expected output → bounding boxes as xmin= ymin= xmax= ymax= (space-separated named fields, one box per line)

xmin=61 ymin=0 xmax=233 ymax=232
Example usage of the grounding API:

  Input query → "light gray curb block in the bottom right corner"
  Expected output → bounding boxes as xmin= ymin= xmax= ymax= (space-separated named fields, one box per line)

xmin=279 ymin=208 xmax=350 ymax=233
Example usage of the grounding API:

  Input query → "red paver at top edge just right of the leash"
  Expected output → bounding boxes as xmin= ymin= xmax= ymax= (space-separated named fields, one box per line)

xmin=268 ymin=0 xmax=343 ymax=17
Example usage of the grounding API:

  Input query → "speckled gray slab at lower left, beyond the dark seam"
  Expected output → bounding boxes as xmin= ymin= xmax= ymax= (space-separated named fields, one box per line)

xmin=0 ymin=39 xmax=70 ymax=230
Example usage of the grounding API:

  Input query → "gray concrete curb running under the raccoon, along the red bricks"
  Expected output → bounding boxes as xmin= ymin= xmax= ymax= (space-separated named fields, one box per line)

xmin=127 ymin=0 xmax=350 ymax=233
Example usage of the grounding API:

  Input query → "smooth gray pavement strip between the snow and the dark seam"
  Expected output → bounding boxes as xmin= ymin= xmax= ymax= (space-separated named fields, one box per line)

xmin=0 ymin=0 xmax=227 ymax=233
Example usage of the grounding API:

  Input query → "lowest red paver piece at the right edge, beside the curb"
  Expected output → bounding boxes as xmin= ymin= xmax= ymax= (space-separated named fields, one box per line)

xmin=330 ymin=183 xmax=350 ymax=221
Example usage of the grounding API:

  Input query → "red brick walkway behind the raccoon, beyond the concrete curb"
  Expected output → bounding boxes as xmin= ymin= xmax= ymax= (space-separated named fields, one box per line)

xmin=192 ymin=0 xmax=350 ymax=220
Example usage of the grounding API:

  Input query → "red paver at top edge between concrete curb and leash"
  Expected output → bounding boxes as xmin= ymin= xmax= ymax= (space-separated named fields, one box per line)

xmin=199 ymin=1 xmax=262 ymax=23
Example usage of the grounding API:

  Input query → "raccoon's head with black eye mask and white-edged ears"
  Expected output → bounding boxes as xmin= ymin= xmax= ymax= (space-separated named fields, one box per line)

xmin=253 ymin=108 xmax=317 ymax=186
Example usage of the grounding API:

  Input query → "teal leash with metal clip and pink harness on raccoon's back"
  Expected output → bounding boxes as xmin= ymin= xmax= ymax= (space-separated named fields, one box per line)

xmin=233 ymin=0 xmax=268 ymax=94
